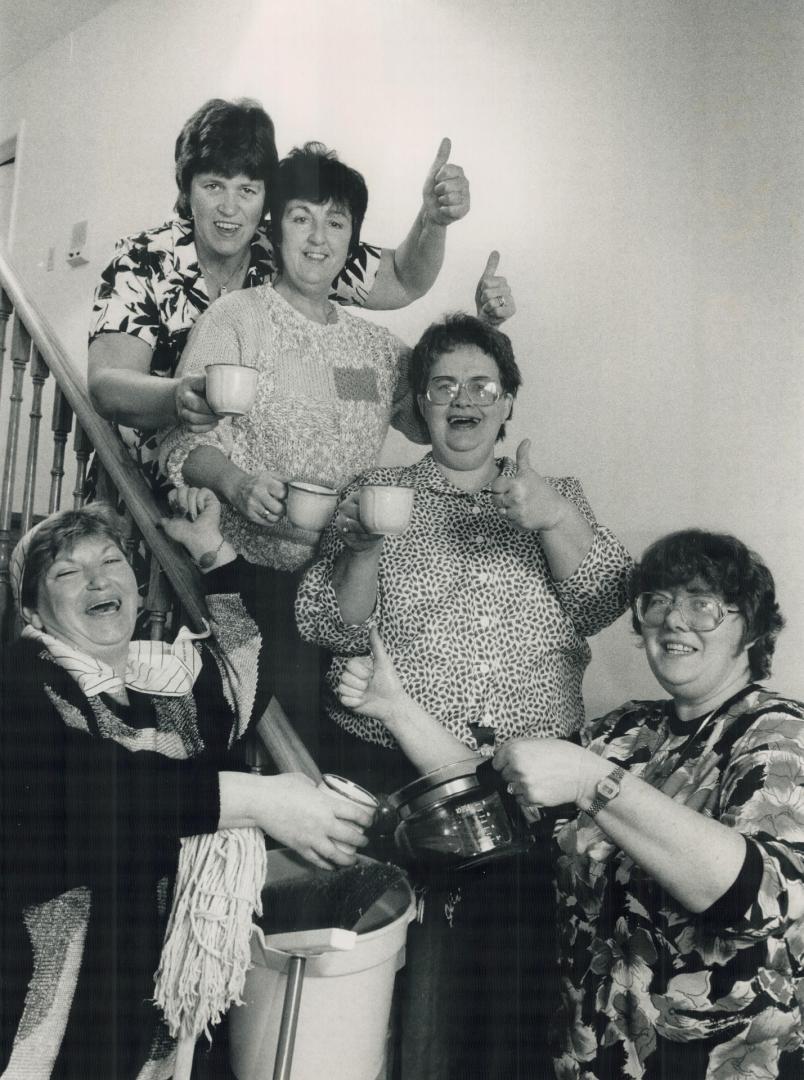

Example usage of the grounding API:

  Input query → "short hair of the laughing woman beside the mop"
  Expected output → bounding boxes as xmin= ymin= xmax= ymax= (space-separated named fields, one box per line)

xmin=19 ymin=502 xmax=125 ymax=609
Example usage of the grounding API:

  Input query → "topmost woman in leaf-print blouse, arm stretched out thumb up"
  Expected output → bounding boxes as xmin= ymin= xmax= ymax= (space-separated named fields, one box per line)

xmin=89 ymin=98 xmax=477 ymax=488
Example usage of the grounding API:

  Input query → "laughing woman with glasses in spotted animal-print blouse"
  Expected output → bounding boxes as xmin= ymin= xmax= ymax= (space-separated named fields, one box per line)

xmin=296 ymin=315 xmax=631 ymax=1080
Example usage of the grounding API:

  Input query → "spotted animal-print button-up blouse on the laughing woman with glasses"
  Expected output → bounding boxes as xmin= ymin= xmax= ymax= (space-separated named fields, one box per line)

xmin=296 ymin=454 xmax=632 ymax=753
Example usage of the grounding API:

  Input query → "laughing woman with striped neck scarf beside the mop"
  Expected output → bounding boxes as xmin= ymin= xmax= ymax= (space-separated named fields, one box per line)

xmin=0 ymin=491 xmax=370 ymax=1080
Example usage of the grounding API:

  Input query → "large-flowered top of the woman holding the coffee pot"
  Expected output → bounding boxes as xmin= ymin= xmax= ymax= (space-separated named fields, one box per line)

xmin=555 ymin=686 xmax=804 ymax=1080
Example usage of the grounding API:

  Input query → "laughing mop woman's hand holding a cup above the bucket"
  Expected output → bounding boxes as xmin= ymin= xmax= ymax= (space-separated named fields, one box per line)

xmin=254 ymin=772 xmax=374 ymax=868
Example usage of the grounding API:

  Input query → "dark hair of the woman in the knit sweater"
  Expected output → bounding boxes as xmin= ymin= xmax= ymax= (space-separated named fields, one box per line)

xmin=268 ymin=143 xmax=369 ymax=264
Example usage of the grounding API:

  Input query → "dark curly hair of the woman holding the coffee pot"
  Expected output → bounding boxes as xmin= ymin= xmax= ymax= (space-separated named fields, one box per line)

xmin=631 ymin=529 xmax=785 ymax=679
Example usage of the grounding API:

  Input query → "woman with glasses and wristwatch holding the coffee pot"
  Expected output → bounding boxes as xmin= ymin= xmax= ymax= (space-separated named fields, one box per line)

xmin=490 ymin=530 xmax=804 ymax=1080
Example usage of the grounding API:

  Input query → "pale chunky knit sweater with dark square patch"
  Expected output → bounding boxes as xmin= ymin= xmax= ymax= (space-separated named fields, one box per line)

xmin=161 ymin=285 xmax=425 ymax=570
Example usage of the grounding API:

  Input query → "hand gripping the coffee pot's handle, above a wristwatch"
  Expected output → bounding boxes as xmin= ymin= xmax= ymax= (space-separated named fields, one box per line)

xmin=494 ymin=739 xmax=606 ymax=809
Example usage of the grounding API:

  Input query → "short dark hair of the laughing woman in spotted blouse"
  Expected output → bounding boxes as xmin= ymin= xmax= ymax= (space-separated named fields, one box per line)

xmin=407 ymin=311 xmax=522 ymax=440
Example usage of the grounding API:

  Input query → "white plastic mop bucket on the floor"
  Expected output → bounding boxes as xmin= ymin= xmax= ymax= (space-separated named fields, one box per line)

xmin=229 ymin=851 xmax=415 ymax=1080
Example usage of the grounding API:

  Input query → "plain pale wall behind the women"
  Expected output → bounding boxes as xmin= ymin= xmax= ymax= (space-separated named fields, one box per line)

xmin=0 ymin=0 xmax=804 ymax=713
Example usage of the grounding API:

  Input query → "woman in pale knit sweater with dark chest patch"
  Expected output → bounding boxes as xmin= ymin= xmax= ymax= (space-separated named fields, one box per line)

xmin=161 ymin=144 xmax=514 ymax=742
